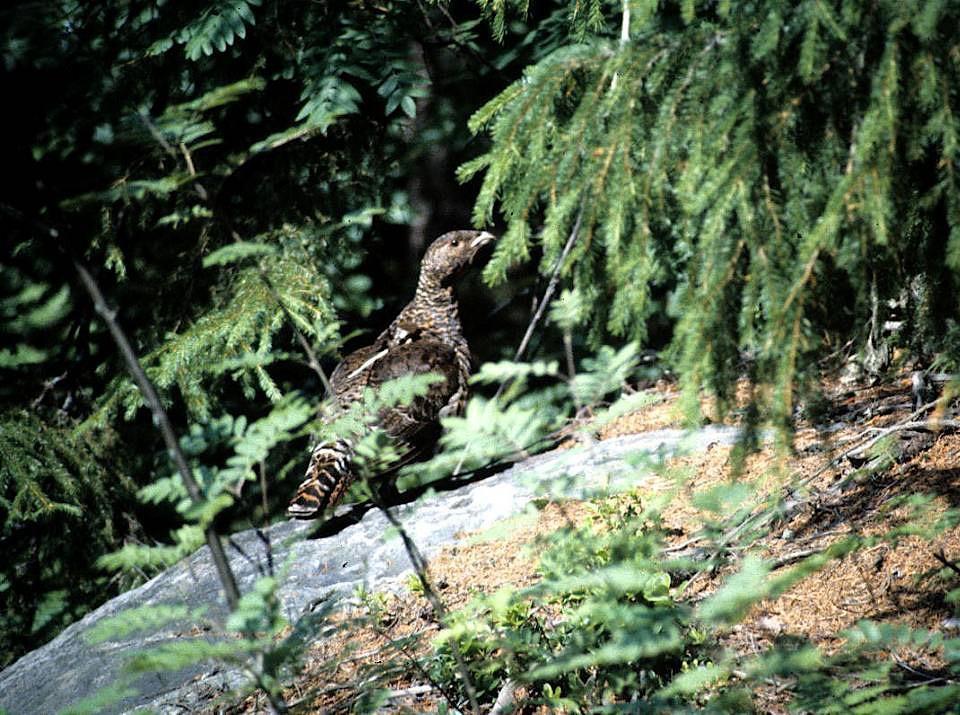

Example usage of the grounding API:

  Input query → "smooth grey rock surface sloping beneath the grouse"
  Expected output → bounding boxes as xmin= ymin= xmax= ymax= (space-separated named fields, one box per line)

xmin=0 ymin=427 xmax=736 ymax=715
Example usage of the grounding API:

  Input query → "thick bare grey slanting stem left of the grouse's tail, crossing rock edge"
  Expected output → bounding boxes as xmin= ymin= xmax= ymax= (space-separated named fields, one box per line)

xmin=73 ymin=259 xmax=240 ymax=611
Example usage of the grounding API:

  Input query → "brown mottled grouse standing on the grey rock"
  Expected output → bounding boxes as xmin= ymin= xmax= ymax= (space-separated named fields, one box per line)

xmin=287 ymin=231 xmax=494 ymax=519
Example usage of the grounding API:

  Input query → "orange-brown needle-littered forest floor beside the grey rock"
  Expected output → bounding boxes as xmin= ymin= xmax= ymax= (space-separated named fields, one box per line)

xmin=232 ymin=375 xmax=960 ymax=713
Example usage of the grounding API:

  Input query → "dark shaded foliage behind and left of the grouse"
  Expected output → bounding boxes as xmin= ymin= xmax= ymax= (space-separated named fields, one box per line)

xmin=0 ymin=0 xmax=548 ymax=663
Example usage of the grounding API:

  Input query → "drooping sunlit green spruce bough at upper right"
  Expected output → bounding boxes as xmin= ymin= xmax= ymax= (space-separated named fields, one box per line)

xmin=460 ymin=0 xmax=960 ymax=424
